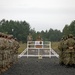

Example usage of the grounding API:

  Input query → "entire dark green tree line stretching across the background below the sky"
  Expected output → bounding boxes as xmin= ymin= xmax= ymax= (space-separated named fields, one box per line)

xmin=0 ymin=19 xmax=75 ymax=42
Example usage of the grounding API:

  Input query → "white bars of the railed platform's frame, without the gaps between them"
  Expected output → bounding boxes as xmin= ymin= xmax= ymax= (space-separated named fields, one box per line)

xmin=18 ymin=41 xmax=59 ymax=58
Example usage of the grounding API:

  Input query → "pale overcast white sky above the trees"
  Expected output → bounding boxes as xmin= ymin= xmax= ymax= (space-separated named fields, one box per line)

xmin=0 ymin=0 xmax=75 ymax=31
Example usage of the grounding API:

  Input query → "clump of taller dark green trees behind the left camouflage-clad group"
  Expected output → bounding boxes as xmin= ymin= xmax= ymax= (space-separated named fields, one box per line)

xmin=0 ymin=19 xmax=30 ymax=42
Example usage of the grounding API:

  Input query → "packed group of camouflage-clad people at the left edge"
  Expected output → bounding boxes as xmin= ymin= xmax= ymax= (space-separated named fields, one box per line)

xmin=0 ymin=32 xmax=19 ymax=73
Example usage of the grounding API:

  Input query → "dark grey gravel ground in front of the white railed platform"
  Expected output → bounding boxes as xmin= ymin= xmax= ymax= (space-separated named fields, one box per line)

xmin=1 ymin=57 xmax=75 ymax=75
